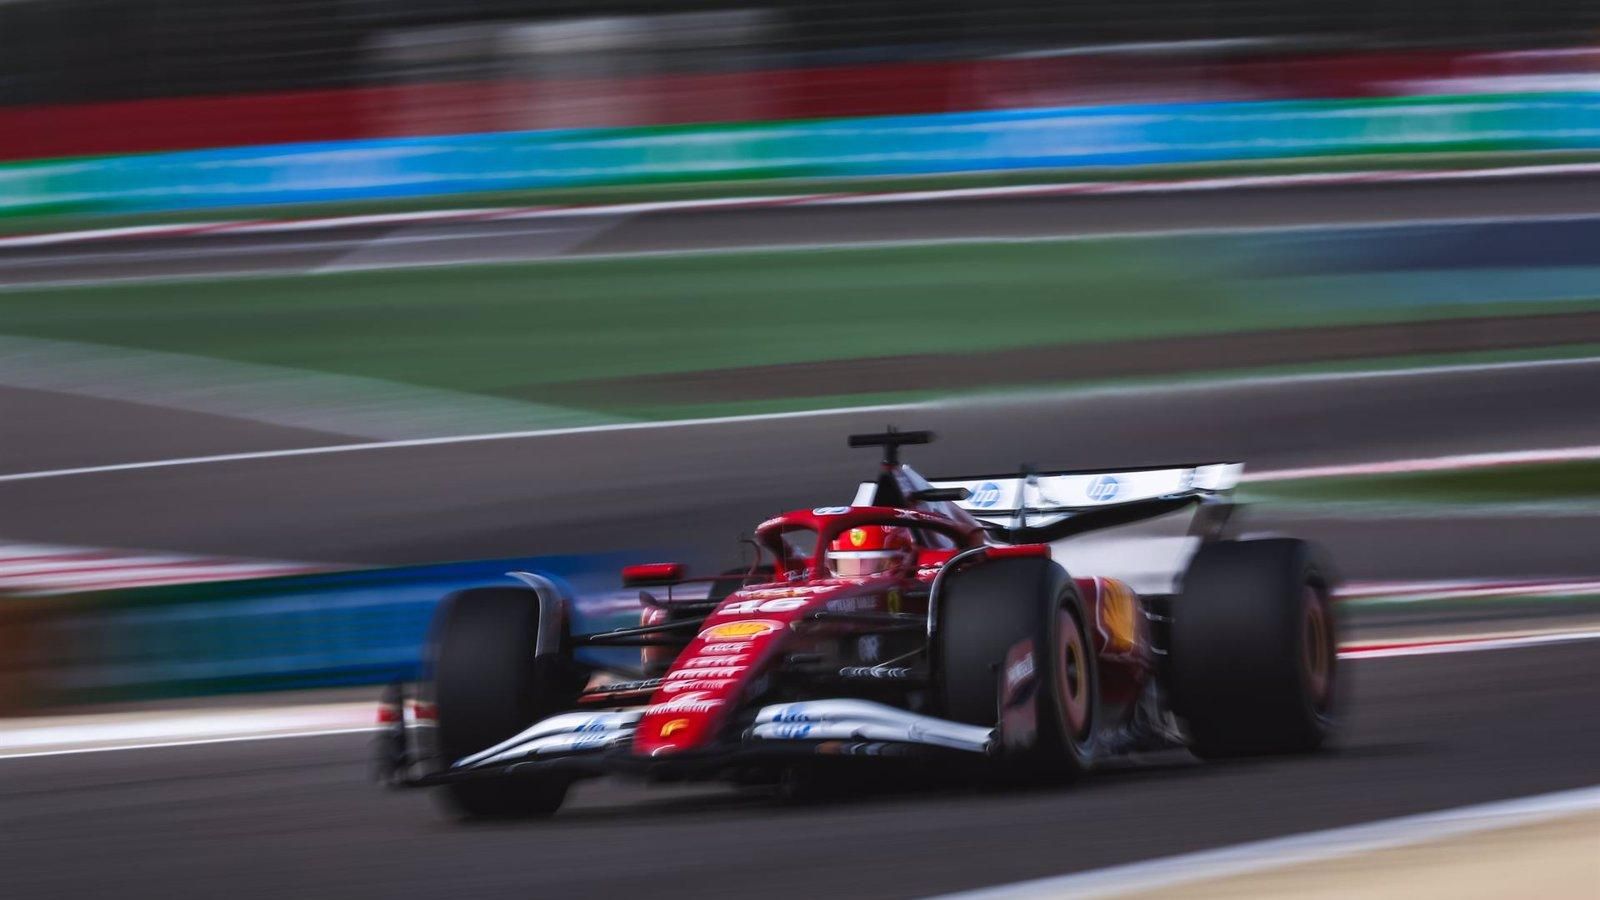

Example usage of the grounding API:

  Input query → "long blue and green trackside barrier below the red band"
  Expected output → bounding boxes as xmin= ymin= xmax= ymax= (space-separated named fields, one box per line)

xmin=0 ymin=93 xmax=1600 ymax=215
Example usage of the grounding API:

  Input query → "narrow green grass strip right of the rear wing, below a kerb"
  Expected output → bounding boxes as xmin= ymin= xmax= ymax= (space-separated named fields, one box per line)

xmin=1243 ymin=461 xmax=1600 ymax=504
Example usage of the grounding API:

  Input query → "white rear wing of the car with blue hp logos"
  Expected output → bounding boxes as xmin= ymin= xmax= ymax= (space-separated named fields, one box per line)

xmin=930 ymin=463 xmax=1245 ymax=543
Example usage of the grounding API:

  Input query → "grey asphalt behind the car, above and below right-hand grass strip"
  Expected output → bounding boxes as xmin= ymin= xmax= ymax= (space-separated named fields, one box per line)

xmin=0 ymin=353 xmax=1600 ymax=578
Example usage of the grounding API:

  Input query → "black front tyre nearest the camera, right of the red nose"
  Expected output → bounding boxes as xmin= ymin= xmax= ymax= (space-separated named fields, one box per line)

xmin=931 ymin=557 xmax=1099 ymax=777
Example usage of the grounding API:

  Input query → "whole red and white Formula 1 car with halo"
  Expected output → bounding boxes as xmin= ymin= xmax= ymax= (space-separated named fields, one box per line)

xmin=379 ymin=431 xmax=1338 ymax=815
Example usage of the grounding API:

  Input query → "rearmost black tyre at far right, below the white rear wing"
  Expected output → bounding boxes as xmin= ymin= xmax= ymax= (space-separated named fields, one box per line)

xmin=1171 ymin=538 xmax=1339 ymax=757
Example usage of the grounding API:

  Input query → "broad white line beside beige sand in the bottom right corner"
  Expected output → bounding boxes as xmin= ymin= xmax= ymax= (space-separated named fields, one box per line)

xmin=936 ymin=786 xmax=1600 ymax=900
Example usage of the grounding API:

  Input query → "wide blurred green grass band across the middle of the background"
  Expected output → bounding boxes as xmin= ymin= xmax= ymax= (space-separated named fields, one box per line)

xmin=0 ymin=239 xmax=1594 ymax=400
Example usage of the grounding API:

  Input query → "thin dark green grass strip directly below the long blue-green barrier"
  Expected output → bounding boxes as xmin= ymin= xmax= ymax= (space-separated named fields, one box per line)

xmin=12 ymin=151 xmax=1600 ymax=234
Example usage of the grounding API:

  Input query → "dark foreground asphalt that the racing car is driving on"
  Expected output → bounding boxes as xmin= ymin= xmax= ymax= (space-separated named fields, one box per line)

xmin=0 ymin=642 xmax=1600 ymax=900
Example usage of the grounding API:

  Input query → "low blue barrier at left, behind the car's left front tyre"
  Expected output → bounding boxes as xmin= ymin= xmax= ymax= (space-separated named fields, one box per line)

xmin=10 ymin=554 xmax=638 ymax=706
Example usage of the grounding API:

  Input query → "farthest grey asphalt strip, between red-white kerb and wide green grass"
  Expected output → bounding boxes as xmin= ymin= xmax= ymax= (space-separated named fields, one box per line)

xmin=9 ymin=166 xmax=1600 ymax=287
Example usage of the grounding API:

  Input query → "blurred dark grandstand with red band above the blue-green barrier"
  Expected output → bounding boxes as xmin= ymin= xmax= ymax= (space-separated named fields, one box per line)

xmin=0 ymin=0 xmax=1600 ymax=160
